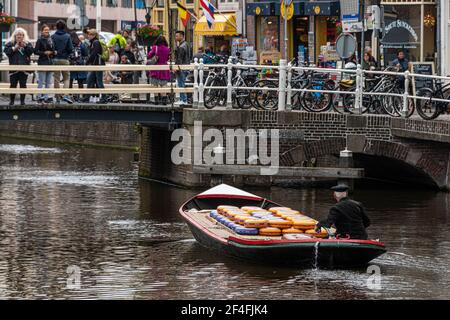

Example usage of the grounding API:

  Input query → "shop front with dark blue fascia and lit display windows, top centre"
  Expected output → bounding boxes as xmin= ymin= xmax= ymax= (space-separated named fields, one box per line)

xmin=247 ymin=0 xmax=340 ymax=64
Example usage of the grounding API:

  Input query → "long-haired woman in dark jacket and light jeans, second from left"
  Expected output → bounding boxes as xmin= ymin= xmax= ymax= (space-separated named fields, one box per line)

xmin=34 ymin=24 xmax=55 ymax=103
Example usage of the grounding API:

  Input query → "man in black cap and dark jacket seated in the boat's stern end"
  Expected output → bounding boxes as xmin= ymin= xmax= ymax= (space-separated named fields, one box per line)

xmin=316 ymin=184 xmax=370 ymax=240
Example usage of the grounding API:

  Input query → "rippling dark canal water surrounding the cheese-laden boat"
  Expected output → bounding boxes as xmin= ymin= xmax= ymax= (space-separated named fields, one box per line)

xmin=0 ymin=139 xmax=450 ymax=299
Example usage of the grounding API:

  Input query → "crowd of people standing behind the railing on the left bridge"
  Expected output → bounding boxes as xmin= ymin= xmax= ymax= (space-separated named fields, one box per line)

xmin=4 ymin=20 xmax=191 ymax=105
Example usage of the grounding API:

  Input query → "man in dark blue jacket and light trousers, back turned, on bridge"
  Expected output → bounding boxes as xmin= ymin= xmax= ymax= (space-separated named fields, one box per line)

xmin=52 ymin=20 xmax=73 ymax=104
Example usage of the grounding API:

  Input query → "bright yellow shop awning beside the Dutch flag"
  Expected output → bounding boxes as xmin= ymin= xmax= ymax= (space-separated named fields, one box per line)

xmin=194 ymin=13 xmax=238 ymax=36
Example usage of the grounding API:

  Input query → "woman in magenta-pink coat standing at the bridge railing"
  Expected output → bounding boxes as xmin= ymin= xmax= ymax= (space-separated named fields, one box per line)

xmin=147 ymin=36 xmax=170 ymax=104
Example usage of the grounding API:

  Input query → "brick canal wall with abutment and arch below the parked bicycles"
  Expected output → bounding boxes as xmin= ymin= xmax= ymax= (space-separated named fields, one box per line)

xmin=139 ymin=109 xmax=450 ymax=189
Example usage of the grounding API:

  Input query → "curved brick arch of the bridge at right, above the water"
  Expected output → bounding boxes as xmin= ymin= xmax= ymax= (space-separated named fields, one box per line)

xmin=280 ymin=138 xmax=449 ymax=188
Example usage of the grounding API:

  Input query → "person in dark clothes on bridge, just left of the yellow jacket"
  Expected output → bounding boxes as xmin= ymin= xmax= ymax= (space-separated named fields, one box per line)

xmin=83 ymin=29 xmax=109 ymax=103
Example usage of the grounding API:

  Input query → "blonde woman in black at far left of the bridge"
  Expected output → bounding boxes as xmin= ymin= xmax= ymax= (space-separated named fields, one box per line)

xmin=4 ymin=28 xmax=34 ymax=106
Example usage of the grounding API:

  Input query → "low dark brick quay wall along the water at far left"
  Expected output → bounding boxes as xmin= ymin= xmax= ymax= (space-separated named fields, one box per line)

xmin=0 ymin=121 xmax=139 ymax=150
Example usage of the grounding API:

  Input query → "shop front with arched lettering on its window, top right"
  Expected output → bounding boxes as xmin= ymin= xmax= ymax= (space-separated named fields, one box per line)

xmin=381 ymin=1 xmax=437 ymax=65
